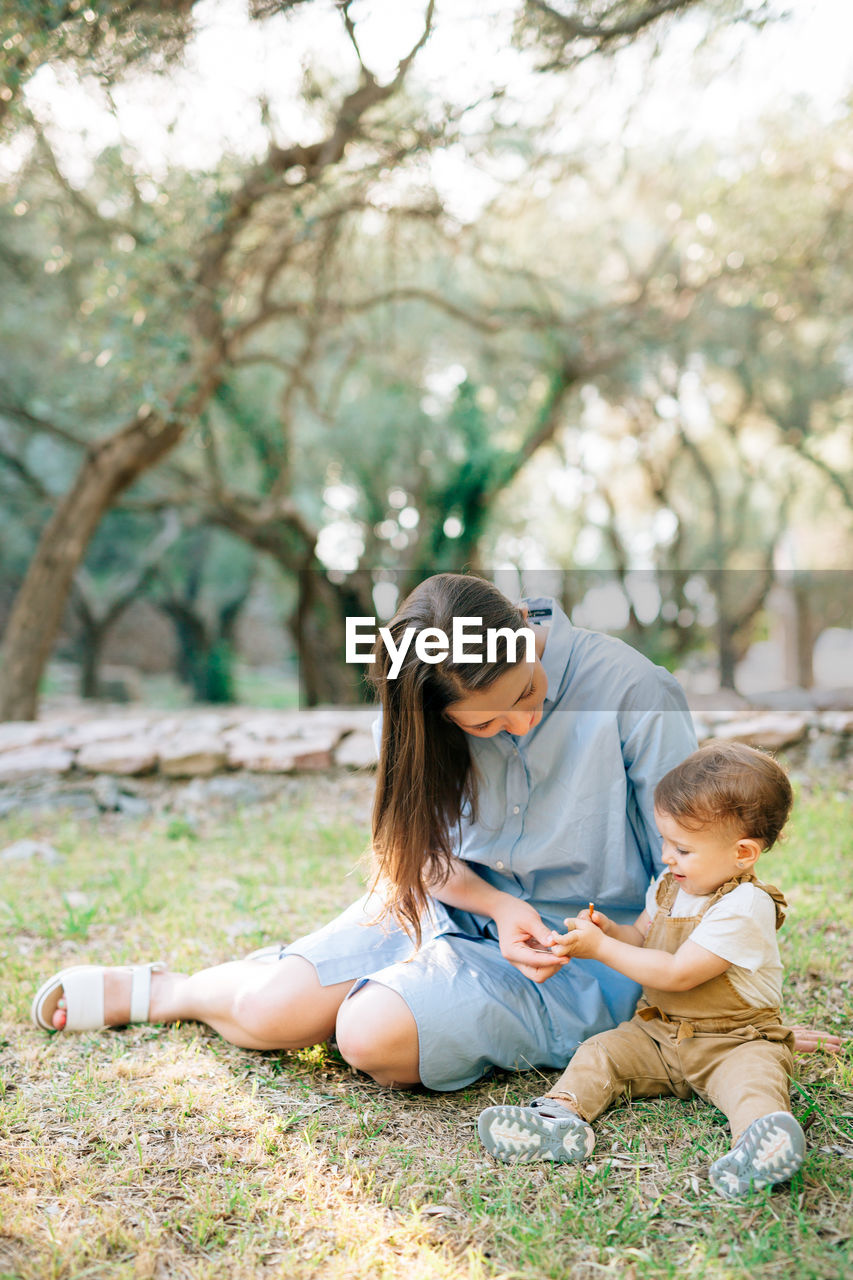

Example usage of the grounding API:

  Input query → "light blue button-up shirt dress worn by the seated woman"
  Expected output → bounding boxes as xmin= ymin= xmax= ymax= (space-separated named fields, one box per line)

xmin=286 ymin=598 xmax=697 ymax=1089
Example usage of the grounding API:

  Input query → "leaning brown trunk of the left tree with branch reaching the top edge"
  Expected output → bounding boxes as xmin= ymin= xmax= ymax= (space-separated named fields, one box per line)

xmin=0 ymin=0 xmax=434 ymax=719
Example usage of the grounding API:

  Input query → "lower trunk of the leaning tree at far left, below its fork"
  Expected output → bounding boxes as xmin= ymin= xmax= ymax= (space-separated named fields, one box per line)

xmin=0 ymin=394 xmax=218 ymax=721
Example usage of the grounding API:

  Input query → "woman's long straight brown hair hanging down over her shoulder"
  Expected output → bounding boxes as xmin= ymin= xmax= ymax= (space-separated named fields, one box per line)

xmin=370 ymin=573 xmax=524 ymax=946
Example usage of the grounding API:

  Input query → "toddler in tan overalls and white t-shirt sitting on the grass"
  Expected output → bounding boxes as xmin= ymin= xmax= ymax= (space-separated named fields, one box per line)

xmin=479 ymin=742 xmax=806 ymax=1198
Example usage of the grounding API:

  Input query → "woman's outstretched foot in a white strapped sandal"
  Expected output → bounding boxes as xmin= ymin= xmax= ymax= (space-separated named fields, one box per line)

xmin=33 ymin=965 xmax=183 ymax=1032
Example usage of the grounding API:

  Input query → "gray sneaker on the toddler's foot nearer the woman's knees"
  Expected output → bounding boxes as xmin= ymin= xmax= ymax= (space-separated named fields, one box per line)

xmin=476 ymin=1098 xmax=596 ymax=1165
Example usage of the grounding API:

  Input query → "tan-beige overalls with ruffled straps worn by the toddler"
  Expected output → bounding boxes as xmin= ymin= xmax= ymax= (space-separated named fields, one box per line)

xmin=547 ymin=873 xmax=794 ymax=1139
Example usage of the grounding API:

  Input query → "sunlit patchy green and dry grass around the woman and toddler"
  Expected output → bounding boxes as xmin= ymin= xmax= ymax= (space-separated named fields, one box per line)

xmin=0 ymin=762 xmax=853 ymax=1280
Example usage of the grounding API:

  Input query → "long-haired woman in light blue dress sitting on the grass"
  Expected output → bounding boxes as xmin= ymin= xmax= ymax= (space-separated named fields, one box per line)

xmin=33 ymin=573 xmax=835 ymax=1089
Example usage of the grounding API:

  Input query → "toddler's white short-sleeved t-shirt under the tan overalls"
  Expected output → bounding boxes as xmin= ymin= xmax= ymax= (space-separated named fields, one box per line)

xmin=646 ymin=873 xmax=783 ymax=1009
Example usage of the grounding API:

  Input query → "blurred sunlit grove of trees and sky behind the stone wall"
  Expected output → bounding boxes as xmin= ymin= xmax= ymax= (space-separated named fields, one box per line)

xmin=0 ymin=0 xmax=853 ymax=719
